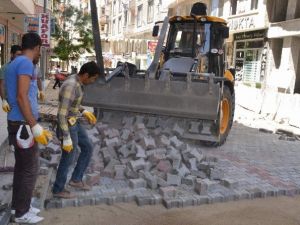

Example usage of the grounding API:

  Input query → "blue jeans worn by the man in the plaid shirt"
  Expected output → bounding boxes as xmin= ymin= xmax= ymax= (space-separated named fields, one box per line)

xmin=52 ymin=122 xmax=93 ymax=194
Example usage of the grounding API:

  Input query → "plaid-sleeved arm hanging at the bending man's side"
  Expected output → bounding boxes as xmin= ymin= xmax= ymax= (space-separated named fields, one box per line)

xmin=57 ymin=85 xmax=76 ymax=138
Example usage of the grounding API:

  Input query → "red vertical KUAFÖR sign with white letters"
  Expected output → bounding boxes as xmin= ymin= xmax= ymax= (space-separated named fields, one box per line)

xmin=39 ymin=13 xmax=51 ymax=47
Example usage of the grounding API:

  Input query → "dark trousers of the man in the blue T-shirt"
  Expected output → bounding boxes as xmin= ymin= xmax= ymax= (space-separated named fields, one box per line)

xmin=7 ymin=121 xmax=39 ymax=217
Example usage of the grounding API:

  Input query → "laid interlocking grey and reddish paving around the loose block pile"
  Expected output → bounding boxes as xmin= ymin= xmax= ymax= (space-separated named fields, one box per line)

xmin=45 ymin=123 xmax=300 ymax=208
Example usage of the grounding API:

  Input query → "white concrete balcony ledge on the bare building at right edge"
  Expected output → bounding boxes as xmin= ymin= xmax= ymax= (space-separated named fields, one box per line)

xmin=268 ymin=19 xmax=300 ymax=38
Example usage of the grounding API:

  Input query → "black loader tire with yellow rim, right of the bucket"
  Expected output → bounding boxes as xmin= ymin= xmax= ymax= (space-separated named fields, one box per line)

xmin=202 ymin=86 xmax=235 ymax=147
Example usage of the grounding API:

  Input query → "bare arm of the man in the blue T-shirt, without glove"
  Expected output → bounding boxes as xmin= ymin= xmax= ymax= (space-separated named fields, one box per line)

xmin=17 ymin=75 xmax=37 ymax=127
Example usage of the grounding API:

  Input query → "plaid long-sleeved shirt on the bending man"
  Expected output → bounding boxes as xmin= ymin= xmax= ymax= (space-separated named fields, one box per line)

xmin=57 ymin=74 xmax=83 ymax=138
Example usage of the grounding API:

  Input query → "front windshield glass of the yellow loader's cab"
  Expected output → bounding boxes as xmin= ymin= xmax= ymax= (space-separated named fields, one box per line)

xmin=168 ymin=22 xmax=210 ymax=57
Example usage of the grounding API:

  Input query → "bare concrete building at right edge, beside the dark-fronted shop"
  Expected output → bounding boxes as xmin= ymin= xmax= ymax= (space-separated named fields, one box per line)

xmin=267 ymin=0 xmax=300 ymax=94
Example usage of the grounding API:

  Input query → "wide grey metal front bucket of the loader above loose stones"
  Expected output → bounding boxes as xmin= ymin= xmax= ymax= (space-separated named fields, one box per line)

xmin=83 ymin=73 xmax=222 ymax=141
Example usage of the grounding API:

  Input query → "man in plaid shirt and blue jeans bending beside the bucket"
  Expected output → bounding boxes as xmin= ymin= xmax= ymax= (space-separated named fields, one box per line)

xmin=52 ymin=62 xmax=100 ymax=198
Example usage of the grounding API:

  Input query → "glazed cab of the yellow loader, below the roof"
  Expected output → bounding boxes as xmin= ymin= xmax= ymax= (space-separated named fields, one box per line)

xmin=163 ymin=16 xmax=229 ymax=76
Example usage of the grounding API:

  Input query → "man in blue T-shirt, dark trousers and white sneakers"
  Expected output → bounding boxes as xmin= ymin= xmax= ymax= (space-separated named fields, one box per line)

xmin=5 ymin=33 xmax=51 ymax=224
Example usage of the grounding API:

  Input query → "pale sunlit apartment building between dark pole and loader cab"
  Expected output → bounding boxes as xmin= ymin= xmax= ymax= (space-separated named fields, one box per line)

xmin=98 ymin=0 xmax=209 ymax=69
